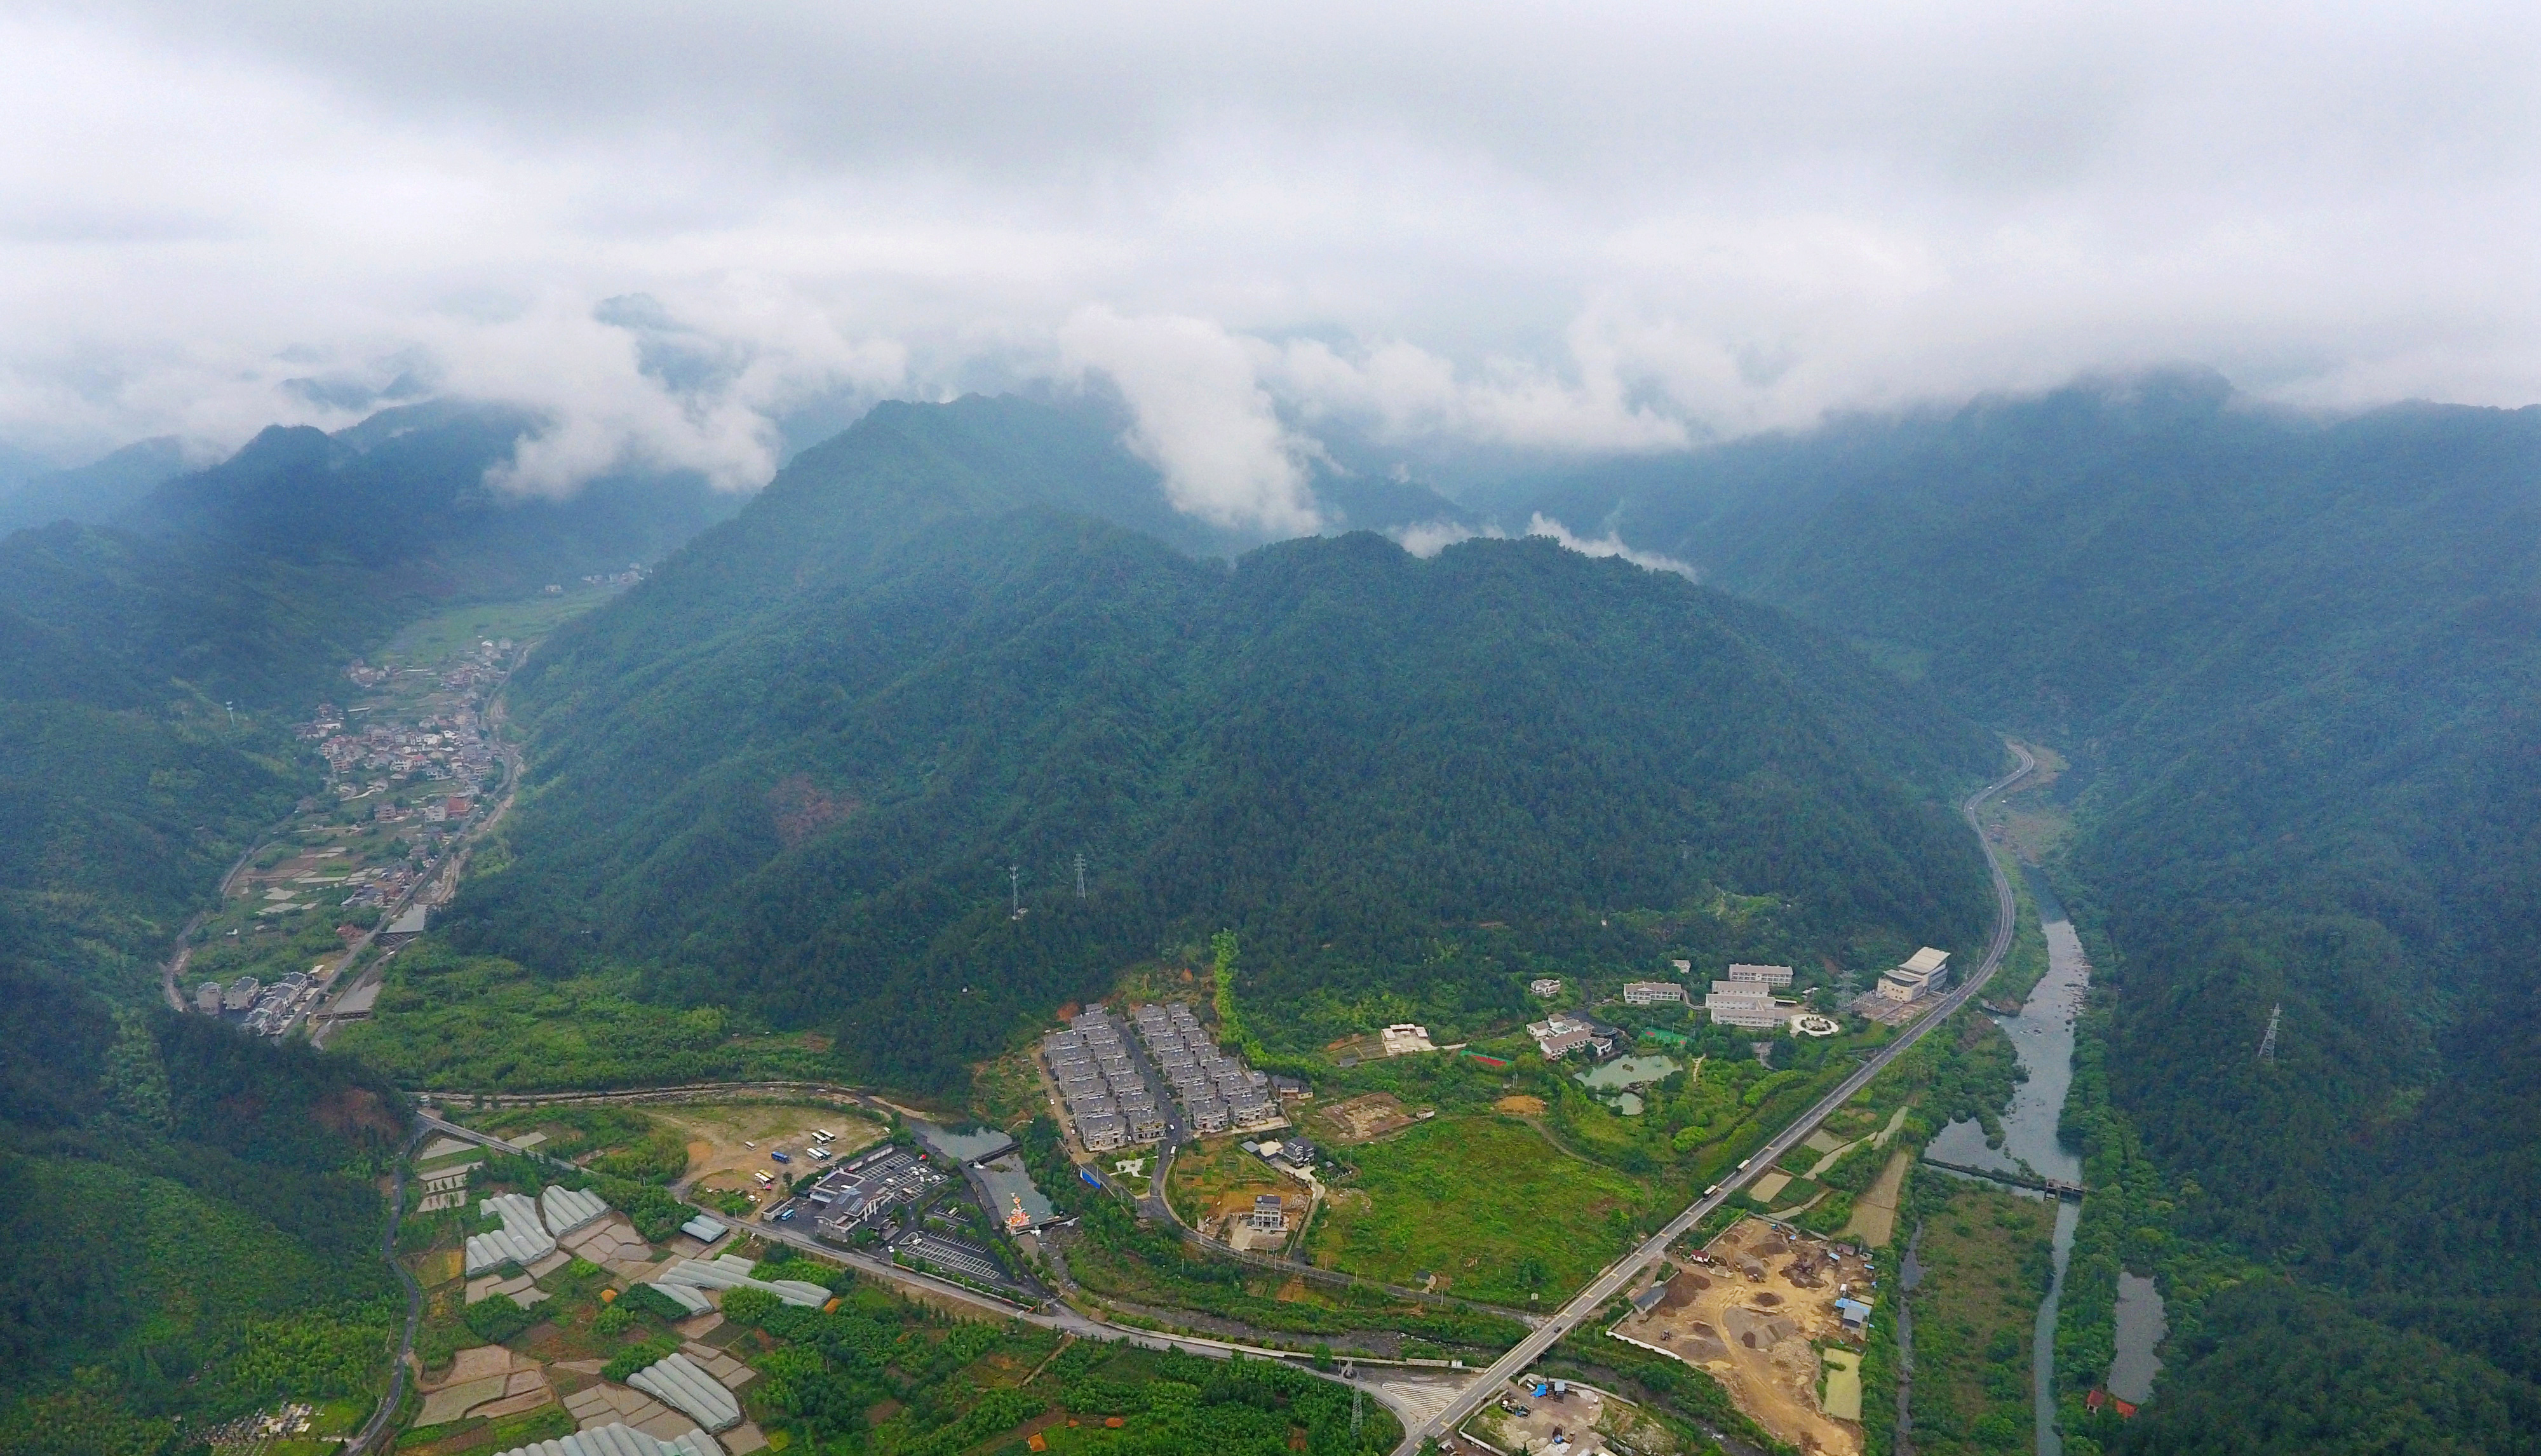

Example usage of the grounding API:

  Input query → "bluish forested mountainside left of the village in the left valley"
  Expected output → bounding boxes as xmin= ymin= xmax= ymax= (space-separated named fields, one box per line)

xmin=0 ymin=404 xmax=732 ymax=996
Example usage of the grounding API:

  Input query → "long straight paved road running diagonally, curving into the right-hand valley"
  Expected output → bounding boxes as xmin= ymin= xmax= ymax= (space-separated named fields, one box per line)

xmin=1395 ymin=747 xmax=2038 ymax=1456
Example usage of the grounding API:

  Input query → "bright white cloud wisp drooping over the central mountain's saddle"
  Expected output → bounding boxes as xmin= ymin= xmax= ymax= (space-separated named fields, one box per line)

xmin=1060 ymin=307 xmax=1321 ymax=536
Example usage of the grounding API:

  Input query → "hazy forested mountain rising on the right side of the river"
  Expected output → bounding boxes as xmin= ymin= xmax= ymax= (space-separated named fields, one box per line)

xmin=1494 ymin=376 xmax=2541 ymax=1448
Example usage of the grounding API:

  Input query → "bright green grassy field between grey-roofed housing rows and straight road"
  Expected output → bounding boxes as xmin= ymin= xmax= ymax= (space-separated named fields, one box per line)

xmin=1309 ymin=1116 xmax=1649 ymax=1306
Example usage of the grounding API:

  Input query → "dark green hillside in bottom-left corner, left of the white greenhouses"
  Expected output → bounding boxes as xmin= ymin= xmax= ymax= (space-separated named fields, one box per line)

xmin=0 ymin=955 xmax=404 ymax=1451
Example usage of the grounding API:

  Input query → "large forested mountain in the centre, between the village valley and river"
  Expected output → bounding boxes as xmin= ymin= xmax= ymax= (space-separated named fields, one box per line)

xmin=447 ymin=386 xmax=2000 ymax=1088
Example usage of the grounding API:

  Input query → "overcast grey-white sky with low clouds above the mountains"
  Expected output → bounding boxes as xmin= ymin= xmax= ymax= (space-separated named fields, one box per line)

xmin=0 ymin=0 xmax=2541 ymax=526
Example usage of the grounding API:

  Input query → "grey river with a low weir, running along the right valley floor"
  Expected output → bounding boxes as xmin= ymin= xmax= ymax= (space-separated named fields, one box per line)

xmin=1924 ymin=874 xmax=2162 ymax=1456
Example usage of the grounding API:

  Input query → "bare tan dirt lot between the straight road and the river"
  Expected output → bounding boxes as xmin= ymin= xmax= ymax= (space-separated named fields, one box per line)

xmin=1614 ymin=1220 xmax=1868 ymax=1456
